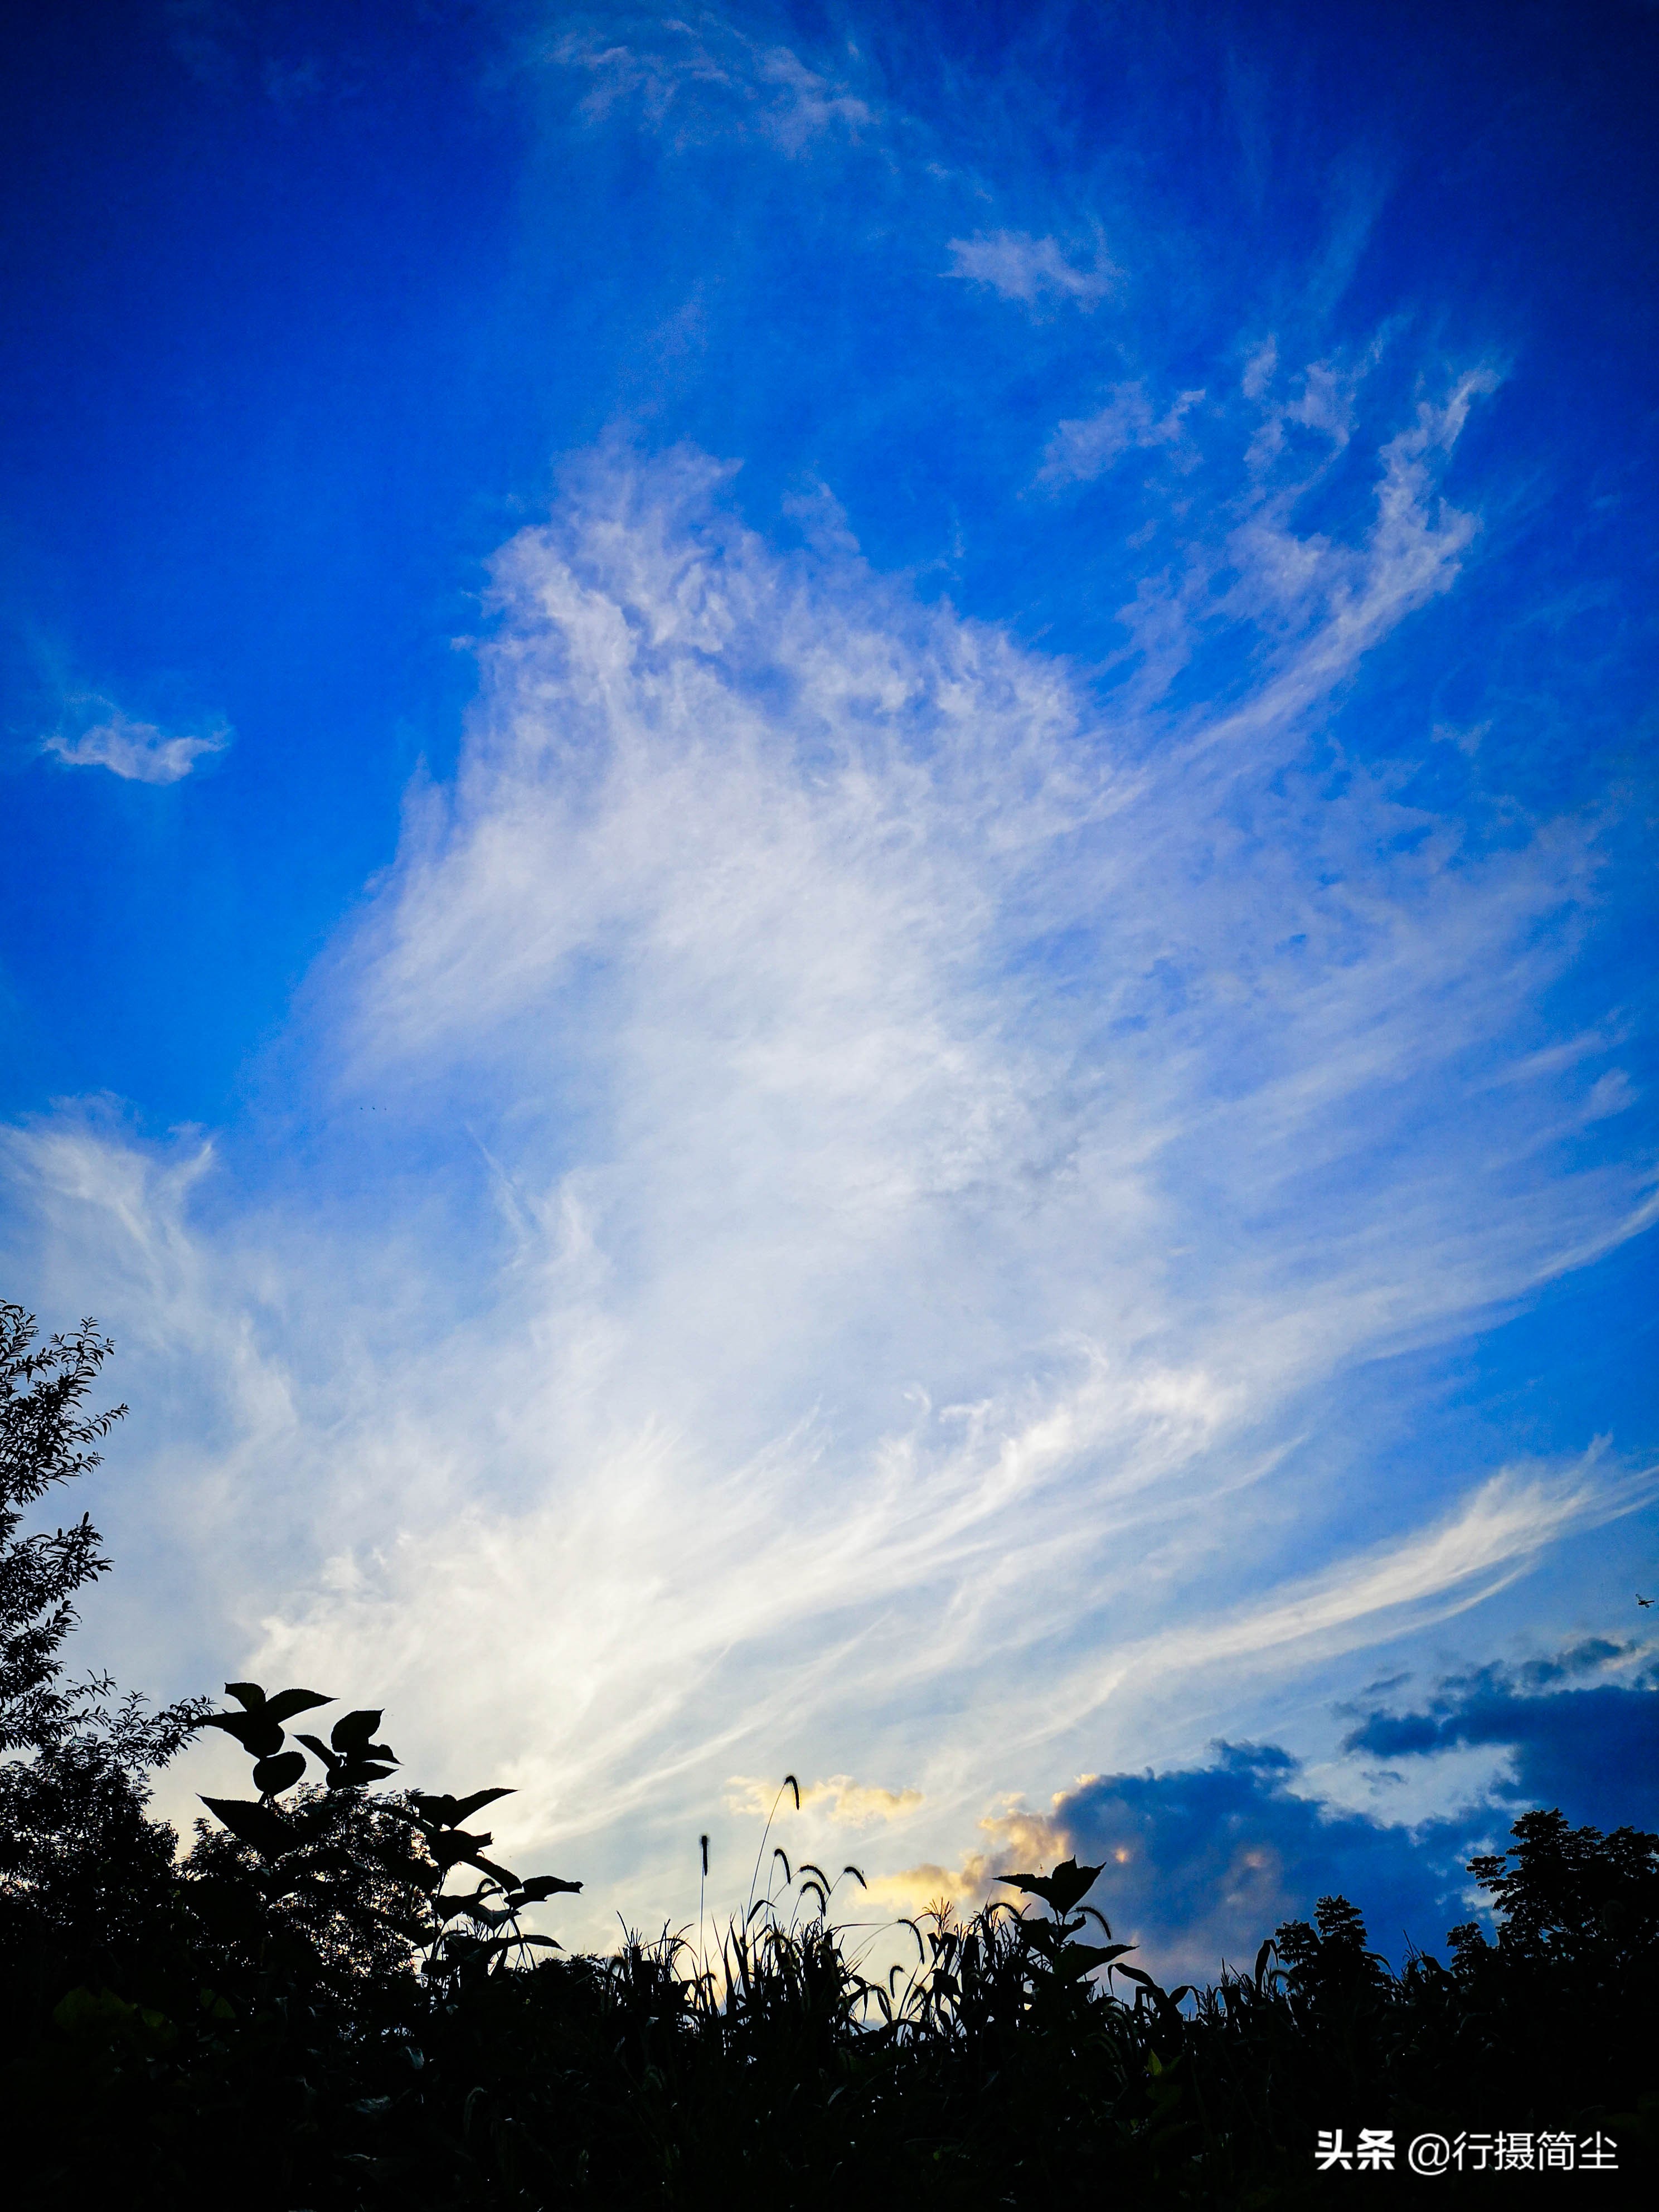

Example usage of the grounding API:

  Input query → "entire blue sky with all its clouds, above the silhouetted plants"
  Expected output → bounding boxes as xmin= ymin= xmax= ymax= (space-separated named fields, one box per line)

xmin=0 ymin=0 xmax=1659 ymax=1971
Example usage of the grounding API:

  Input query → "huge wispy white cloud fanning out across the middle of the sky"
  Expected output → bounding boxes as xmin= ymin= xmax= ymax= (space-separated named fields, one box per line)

xmin=9 ymin=407 xmax=1650 ymax=1931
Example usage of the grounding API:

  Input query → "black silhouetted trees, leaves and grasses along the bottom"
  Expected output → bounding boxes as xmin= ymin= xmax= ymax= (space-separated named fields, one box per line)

xmin=0 ymin=1307 xmax=1659 ymax=2212
